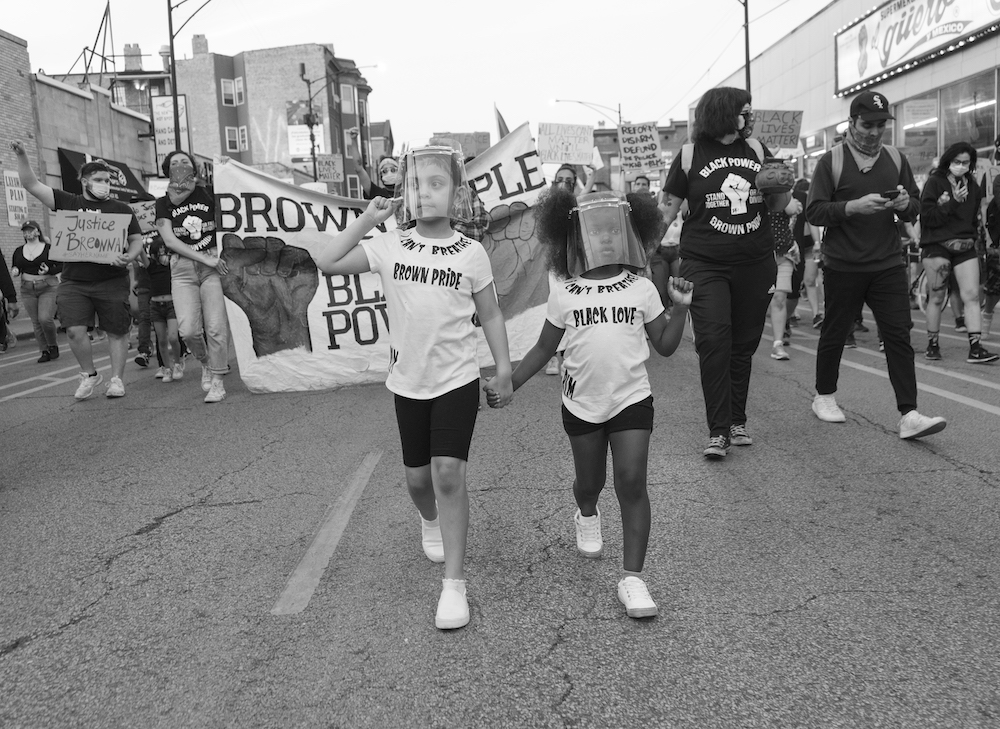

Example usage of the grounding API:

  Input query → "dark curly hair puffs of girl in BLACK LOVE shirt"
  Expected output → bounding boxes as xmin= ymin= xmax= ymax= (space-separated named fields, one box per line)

xmin=535 ymin=189 xmax=663 ymax=279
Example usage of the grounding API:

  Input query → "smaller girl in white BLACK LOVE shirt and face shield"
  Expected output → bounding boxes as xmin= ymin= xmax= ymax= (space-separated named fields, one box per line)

xmin=486 ymin=190 xmax=691 ymax=618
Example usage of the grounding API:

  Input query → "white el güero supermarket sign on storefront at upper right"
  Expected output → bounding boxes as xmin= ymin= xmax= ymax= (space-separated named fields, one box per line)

xmin=836 ymin=0 xmax=1000 ymax=93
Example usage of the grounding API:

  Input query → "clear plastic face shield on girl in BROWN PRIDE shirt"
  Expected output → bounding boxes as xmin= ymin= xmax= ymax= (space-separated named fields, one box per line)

xmin=396 ymin=144 xmax=472 ymax=223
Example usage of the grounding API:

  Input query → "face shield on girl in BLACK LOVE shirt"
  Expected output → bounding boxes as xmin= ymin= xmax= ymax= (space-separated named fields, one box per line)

xmin=566 ymin=192 xmax=646 ymax=276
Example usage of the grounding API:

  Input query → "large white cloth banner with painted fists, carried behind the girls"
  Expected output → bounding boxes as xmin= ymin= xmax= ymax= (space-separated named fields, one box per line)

xmin=215 ymin=125 xmax=548 ymax=392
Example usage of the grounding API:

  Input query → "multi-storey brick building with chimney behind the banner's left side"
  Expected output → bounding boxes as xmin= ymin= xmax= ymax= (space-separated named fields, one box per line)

xmin=177 ymin=35 xmax=372 ymax=197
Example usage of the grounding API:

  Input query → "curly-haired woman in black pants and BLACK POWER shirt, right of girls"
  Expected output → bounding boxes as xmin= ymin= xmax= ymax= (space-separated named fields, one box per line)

xmin=664 ymin=87 xmax=790 ymax=459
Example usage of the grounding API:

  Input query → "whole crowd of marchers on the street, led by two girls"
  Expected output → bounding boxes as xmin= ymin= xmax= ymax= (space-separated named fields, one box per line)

xmin=0 ymin=88 xmax=1000 ymax=630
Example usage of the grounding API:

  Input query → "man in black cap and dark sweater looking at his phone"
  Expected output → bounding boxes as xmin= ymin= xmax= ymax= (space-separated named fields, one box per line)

xmin=806 ymin=91 xmax=947 ymax=439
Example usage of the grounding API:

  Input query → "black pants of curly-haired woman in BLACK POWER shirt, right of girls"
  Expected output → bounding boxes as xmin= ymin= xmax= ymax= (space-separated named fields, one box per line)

xmin=681 ymin=254 xmax=777 ymax=436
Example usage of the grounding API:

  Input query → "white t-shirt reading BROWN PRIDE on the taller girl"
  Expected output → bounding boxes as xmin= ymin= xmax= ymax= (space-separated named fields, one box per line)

xmin=361 ymin=229 xmax=493 ymax=400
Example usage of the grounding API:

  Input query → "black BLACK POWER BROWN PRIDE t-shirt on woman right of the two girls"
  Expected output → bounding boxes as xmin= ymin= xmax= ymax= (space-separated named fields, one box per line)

xmin=663 ymin=139 xmax=773 ymax=264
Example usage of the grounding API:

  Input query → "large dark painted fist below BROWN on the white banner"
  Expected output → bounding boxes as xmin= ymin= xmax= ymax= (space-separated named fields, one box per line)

xmin=222 ymin=233 xmax=319 ymax=357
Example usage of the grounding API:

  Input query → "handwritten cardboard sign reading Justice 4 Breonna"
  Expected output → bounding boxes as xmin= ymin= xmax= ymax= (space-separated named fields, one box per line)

xmin=49 ymin=210 xmax=132 ymax=264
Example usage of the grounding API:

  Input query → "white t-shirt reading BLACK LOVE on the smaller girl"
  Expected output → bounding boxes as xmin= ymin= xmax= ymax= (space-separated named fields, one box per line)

xmin=545 ymin=270 xmax=664 ymax=423
